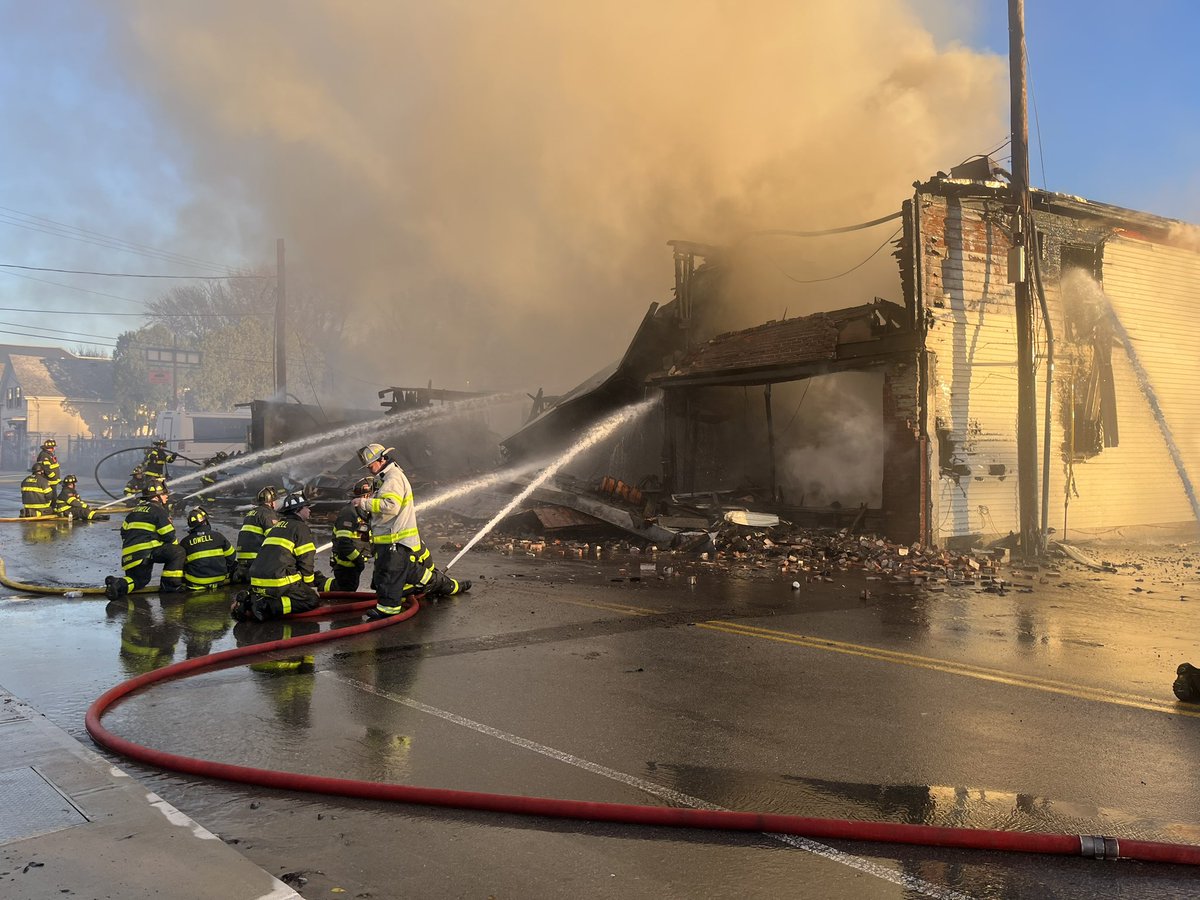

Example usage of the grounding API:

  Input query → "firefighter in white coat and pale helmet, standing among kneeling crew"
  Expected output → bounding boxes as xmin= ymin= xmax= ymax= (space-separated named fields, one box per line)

xmin=353 ymin=444 xmax=470 ymax=619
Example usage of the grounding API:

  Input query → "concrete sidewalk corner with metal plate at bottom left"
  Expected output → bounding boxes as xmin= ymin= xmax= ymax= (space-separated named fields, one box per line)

xmin=0 ymin=686 xmax=300 ymax=900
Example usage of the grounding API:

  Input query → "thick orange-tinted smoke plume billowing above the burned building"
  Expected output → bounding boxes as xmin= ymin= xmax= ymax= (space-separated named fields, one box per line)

xmin=114 ymin=0 xmax=1007 ymax=391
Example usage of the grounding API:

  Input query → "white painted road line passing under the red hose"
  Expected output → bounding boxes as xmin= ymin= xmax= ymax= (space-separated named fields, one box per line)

xmin=320 ymin=670 xmax=972 ymax=900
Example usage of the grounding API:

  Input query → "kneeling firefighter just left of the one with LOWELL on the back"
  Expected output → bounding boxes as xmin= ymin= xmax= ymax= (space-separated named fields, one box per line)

xmin=104 ymin=481 xmax=185 ymax=600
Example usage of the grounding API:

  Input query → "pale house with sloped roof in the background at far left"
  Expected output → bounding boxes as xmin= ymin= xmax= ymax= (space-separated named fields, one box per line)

xmin=0 ymin=344 xmax=116 ymax=470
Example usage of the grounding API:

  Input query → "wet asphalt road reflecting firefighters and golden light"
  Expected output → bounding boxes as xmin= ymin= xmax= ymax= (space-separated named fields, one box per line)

xmin=0 ymin=485 xmax=1200 ymax=898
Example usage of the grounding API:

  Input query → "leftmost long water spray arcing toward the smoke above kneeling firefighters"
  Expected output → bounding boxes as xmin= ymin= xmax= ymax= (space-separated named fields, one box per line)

xmin=175 ymin=394 xmax=521 ymax=500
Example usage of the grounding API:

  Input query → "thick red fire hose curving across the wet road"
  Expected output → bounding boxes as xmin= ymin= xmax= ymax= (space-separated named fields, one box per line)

xmin=85 ymin=592 xmax=1200 ymax=865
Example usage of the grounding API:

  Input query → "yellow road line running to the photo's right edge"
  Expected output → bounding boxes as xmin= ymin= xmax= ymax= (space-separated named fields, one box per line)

xmin=696 ymin=620 xmax=1200 ymax=719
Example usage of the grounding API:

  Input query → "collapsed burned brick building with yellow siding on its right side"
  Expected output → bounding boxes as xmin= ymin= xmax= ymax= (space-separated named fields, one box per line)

xmin=508 ymin=168 xmax=1200 ymax=547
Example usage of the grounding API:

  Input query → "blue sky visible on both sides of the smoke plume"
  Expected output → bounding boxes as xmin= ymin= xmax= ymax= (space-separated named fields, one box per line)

xmin=0 ymin=0 xmax=1200 ymax=362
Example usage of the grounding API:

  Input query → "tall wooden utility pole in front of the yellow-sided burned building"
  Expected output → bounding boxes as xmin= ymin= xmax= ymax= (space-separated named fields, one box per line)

xmin=1008 ymin=0 xmax=1042 ymax=557
